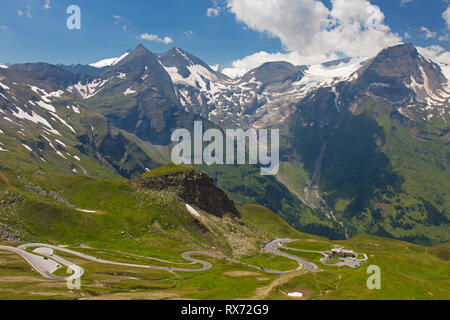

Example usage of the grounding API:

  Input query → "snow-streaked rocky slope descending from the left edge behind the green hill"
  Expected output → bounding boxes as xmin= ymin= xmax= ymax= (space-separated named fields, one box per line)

xmin=0 ymin=64 xmax=160 ymax=177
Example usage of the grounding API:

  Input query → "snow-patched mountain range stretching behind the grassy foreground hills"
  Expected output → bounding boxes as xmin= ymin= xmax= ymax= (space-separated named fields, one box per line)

xmin=0 ymin=44 xmax=450 ymax=245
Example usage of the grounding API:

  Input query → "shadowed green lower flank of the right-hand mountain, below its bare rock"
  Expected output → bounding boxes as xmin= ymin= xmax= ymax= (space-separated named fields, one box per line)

xmin=288 ymin=95 xmax=450 ymax=245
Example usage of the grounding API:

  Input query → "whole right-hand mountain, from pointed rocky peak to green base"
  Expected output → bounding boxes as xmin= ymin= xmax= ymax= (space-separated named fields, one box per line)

xmin=285 ymin=45 xmax=450 ymax=244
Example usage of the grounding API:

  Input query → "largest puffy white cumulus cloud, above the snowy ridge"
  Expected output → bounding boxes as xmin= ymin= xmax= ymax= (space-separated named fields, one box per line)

xmin=223 ymin=0 xmax=402 ymax=77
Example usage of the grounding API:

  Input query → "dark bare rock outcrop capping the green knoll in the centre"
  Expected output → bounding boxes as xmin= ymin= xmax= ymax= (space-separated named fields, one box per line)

xmin=134 ymin=169 xmax=240 ymax=217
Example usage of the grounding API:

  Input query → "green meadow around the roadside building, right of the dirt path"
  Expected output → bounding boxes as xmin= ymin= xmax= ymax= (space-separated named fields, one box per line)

xmin=270 ymin=235 xmax=450 ymax=300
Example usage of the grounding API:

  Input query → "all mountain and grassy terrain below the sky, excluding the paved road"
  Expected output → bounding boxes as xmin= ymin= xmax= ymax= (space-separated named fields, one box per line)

xmin=0 ymin=44 xmax=450 ymax=299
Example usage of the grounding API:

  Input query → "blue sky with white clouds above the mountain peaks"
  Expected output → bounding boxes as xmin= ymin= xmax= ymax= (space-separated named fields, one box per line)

xmin=0 ymin=0 xmax=450 ymax=76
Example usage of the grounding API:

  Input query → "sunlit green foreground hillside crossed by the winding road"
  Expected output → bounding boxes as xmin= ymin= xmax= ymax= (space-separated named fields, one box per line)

xmin=0 ymin=192 xmax=450 ymax=299
